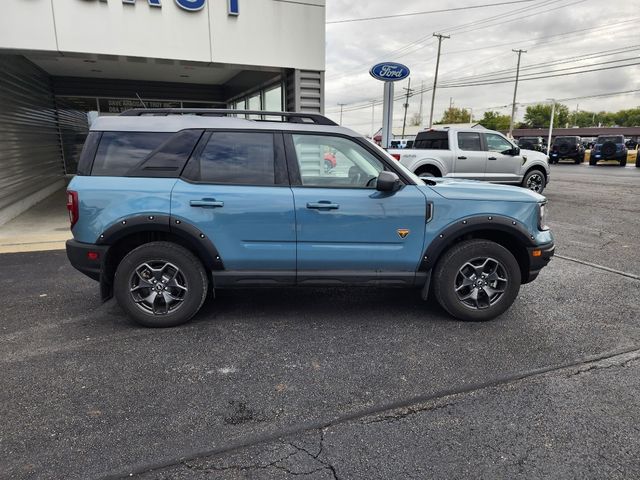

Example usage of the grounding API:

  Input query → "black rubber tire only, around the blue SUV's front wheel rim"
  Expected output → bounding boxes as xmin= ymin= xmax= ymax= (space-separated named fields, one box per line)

xmin=431 ymin=239 xmax=522 ymax=322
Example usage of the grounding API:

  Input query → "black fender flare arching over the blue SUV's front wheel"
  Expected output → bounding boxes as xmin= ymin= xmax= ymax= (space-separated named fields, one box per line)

xmin=418 ymin=215 xmax=536 ymax=272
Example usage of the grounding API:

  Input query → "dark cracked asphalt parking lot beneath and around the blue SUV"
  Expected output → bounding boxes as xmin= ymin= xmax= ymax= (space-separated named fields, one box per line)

xmin=0 ymin=164 xmax=640 ymax=479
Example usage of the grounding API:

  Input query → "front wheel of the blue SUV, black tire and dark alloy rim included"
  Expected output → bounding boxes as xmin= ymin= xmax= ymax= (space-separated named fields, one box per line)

xmin=433 ymin=239 xmax=521 ymax=321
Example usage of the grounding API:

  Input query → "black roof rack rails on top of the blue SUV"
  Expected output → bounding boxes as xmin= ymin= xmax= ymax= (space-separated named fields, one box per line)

xmin=120 ymin=108 xmax=338 ymax=126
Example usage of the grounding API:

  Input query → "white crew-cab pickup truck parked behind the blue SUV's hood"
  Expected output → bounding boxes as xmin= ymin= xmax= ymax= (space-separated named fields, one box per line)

xmin=388 ymin=128 xmax=550 ymax=193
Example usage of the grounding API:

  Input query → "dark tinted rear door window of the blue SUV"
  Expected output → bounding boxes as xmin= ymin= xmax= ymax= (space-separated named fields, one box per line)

xmin=183 ymin=132 xmax=275 ymax=185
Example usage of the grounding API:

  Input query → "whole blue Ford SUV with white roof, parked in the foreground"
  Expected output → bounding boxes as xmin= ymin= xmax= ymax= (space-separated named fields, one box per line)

xmin=67 ymin=109 xmax=554 ymax=327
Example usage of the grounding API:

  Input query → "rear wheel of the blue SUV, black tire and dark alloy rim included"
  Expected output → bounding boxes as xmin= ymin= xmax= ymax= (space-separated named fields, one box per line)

xmin=114 ymin=242 xmax=209 ymax=327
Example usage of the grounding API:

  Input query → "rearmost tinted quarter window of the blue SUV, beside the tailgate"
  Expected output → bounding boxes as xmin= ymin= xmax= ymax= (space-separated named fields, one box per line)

xmin=91 ymin=132 xmax=172 ymax=177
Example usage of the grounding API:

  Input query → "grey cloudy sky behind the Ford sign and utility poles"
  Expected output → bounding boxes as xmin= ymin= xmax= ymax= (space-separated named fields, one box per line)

xmin=325 ymin=0 xmax=640 ymax=134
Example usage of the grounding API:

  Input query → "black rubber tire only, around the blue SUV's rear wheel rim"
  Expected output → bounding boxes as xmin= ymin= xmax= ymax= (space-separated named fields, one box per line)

xmin=114 ymin=242 xmax=209 ymax=327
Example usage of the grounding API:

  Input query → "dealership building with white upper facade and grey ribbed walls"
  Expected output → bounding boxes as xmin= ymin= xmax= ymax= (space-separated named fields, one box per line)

xmin=0 ymin=0 xmax=325 ymax=224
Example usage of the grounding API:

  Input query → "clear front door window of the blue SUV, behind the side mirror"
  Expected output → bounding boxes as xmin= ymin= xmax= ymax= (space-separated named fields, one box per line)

xmin=291 ymin=134 xmax=385 ymax=188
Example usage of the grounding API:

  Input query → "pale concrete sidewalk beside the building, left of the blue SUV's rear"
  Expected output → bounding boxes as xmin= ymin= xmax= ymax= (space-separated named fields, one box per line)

xmin=0 ymin=189 xmax=71 ymax=253
